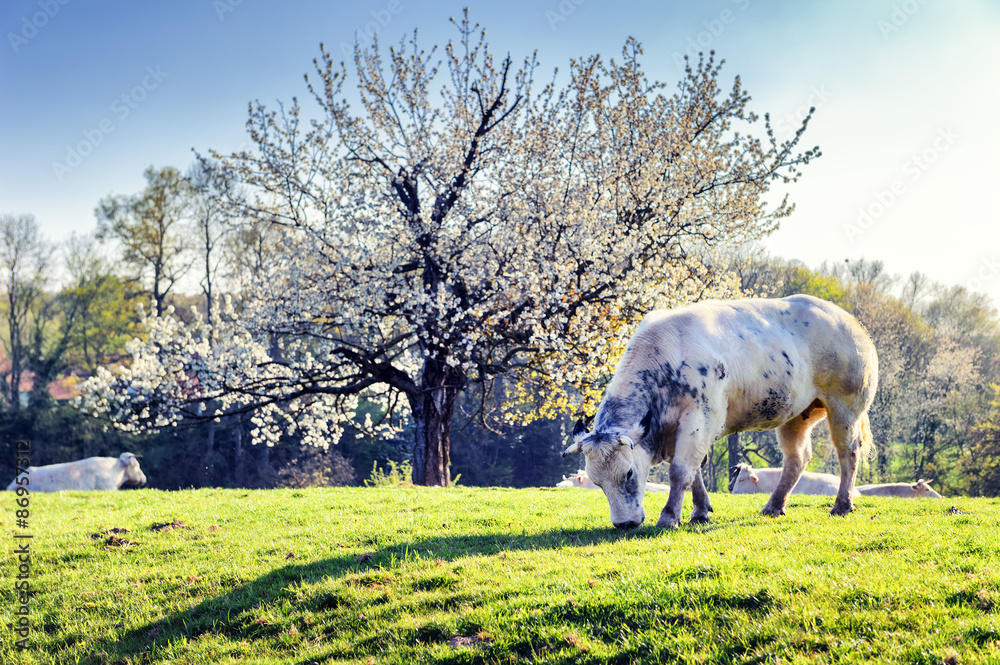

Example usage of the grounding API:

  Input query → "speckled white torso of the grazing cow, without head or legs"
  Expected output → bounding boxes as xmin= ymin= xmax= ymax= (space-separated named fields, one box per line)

xmin=628 ymin=295 xmax=878 ymax=437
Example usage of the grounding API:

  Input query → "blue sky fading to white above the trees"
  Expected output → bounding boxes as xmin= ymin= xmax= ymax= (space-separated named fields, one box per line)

xmin=0 ymin=0 xmax=1000 ymax=302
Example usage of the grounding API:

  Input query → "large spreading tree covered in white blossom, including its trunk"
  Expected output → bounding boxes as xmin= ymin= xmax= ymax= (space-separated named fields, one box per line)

xmin=78 ymin=16 xmax=818 ymax=485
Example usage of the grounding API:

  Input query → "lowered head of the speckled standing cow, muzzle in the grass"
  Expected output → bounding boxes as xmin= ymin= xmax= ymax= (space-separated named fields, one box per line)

xmin=562 ymin=411 xmax=653 ymax=529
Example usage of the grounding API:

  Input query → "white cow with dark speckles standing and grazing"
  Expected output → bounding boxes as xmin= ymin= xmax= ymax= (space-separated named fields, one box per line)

xmin=563 ymin=295 xmax=878 ymax=529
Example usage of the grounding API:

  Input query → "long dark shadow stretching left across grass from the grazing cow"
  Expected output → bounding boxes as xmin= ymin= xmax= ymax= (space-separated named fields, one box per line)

xmin=97 ymin=526 xmax=668 ymax=665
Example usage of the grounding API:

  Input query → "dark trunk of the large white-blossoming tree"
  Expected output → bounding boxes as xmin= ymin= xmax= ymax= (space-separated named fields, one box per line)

xmin=409 ymin=359 xmax=462 ymax=487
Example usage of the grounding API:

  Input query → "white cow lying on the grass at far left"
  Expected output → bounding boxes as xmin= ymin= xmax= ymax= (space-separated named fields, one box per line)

xmin=7 ymin=453 xmax=146 ymax=492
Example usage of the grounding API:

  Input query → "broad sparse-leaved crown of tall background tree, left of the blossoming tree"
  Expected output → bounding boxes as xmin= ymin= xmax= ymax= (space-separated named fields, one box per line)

xmin=94 ymin=166 xmax=191 ymax=314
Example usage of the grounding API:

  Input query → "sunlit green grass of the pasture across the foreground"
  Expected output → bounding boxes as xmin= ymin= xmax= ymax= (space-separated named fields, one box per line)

xmin=0 ymin=488 xmax=1000 ymax=665
